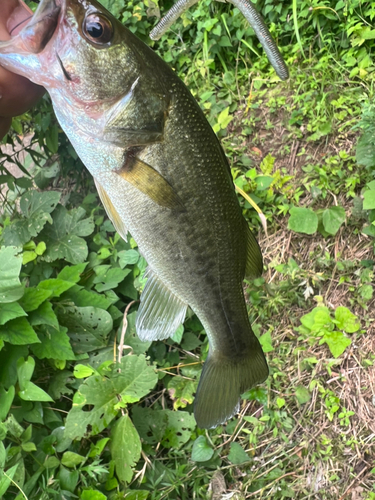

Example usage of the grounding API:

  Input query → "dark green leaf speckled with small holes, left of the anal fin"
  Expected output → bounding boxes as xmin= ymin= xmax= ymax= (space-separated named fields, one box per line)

xmin=58 ymin=307 xmax=113 ymax=354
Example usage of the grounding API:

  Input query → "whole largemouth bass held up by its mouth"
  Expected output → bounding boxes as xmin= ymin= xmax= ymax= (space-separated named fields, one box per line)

xmin=0 ymin=0 xmax=268 ymax=428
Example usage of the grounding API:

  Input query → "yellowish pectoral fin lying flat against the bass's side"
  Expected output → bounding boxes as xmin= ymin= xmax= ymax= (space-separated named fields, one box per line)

xmin=117 ymin=157 xmax=184 ymax=210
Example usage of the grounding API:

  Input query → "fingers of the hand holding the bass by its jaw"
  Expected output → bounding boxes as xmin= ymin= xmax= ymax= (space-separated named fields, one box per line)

xmin=0 ymin=0 xmax=44 ymax=140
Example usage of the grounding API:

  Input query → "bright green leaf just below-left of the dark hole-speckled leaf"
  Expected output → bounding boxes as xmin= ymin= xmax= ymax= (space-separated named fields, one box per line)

xmin=31 ymin=325 xmax=75 ymax=360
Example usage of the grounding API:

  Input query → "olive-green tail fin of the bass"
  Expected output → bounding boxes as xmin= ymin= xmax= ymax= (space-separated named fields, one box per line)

xmin=194 ymin=339 xmax=268 ymax=429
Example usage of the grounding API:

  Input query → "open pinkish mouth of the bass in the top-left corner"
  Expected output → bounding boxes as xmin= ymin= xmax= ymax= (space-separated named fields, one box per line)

xmin=0 ymin=0 xmax=64 ymax=54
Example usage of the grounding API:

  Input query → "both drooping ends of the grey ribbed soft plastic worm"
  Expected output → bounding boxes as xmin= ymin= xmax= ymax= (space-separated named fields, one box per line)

xmin=150 ymin=0 xmax=289 ymax=80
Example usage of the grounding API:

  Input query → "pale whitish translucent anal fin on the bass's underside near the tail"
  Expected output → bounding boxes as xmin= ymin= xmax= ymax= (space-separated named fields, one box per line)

xmin=135 ymin=272 xmax=187 ymax=341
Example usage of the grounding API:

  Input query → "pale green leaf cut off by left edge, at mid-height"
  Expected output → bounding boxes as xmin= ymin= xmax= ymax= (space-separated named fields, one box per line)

xmin=0 ymin=247 xmax=24 ymax=304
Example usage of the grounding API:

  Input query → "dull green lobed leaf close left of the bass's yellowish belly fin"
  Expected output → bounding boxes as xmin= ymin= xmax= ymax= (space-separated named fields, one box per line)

xmin=40 ymin=205 xmax=95 ymax=264
